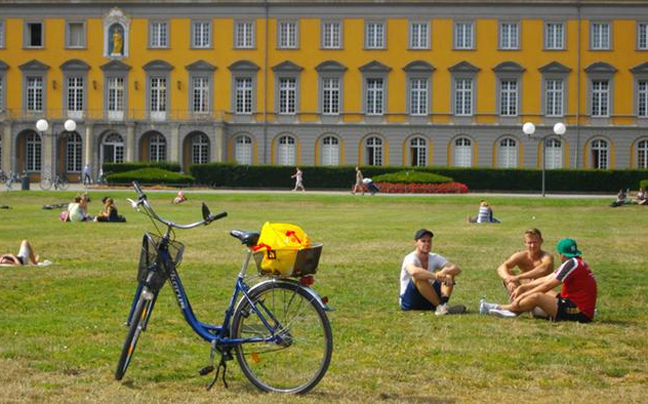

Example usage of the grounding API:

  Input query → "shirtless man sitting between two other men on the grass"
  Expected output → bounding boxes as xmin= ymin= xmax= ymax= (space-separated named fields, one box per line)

xmin=497 ymin=228 xmax=553 ymax=297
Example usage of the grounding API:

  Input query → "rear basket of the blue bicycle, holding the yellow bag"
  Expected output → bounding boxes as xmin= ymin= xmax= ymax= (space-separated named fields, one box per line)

xmin=254 ymin=243 xmax=322 ymax=277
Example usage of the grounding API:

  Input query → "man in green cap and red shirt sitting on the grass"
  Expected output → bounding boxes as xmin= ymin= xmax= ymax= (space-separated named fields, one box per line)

xmin=482 ymin=238 xmax=597 ymax=323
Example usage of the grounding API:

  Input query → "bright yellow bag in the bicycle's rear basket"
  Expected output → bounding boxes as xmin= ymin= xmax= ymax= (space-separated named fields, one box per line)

xmin=254 ymin=222 xmax=310 ymax=276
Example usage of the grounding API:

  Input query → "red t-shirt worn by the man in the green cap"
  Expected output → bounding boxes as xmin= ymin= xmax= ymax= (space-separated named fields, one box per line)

xmin=554 ymin=257 xmax=597 ymax=319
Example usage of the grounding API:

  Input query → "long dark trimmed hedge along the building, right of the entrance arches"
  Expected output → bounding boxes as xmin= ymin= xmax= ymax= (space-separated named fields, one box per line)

xmin=189 ymin=163 xmax=648 ymax=194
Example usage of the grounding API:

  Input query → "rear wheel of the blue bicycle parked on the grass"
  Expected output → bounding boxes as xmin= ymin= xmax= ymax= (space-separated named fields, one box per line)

xmin=232 ymin=282 xmax=333 ymax=394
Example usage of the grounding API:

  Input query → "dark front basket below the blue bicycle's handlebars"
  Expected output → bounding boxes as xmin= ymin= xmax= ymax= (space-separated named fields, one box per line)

xmin=137 ymin=233 xmax=184 ymax=289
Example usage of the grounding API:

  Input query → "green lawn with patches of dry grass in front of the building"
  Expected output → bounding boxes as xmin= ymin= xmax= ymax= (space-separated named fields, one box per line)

xmin=0 ymin=191 xmax=648 ymax=403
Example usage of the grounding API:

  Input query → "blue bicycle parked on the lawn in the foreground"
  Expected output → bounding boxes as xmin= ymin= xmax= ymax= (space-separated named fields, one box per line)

xmin=115 ymin=182 xmax=333 ymax=394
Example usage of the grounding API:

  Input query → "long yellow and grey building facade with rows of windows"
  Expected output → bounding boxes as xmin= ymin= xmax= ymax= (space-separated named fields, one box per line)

xmin=0 ymin=0 xmax=648 ymax=178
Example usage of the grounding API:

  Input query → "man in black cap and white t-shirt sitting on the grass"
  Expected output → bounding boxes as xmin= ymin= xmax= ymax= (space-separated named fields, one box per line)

xmin=400 ymin=229 xmax=466 ymax=316
